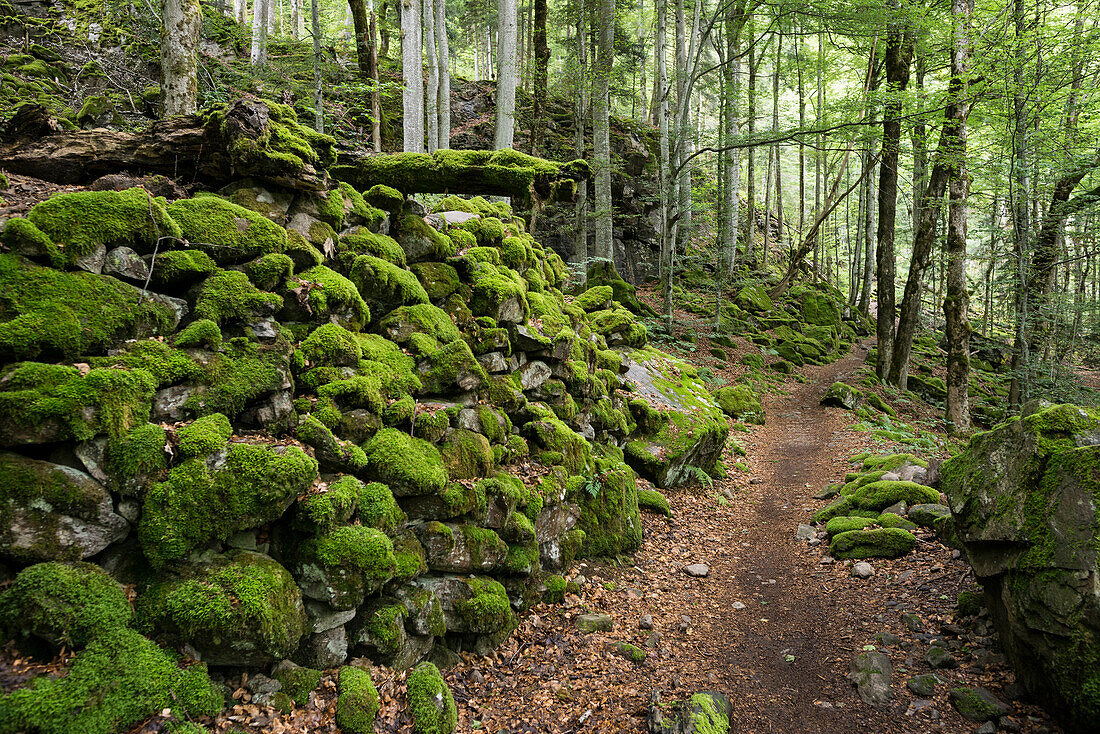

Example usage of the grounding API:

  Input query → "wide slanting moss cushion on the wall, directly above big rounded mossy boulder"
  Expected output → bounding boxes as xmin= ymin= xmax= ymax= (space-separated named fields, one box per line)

xmin=139 ymin=443 xmax=317 ymax=567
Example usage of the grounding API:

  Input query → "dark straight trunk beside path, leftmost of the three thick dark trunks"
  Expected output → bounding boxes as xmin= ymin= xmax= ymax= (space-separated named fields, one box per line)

xmin=875 ymin=21 xmax=916 ymax=382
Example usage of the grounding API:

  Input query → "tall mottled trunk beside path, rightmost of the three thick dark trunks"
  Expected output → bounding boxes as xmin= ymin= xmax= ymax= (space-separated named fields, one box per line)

xmin=944 ymin=0 xmax=970 ymax=434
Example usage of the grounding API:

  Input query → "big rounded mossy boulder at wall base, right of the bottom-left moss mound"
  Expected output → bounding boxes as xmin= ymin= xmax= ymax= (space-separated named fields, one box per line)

xmin=136 ymin=550 xmax=306 ymax=666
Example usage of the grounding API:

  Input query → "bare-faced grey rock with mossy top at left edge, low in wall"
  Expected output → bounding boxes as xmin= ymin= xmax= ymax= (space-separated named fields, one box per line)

xmin=0 ymin=452 xmax=130 ymax=562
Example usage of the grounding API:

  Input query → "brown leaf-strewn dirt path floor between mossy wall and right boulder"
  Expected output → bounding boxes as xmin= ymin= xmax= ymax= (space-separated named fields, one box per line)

xmin=413 ymin=332 xmax=1058 ymax=734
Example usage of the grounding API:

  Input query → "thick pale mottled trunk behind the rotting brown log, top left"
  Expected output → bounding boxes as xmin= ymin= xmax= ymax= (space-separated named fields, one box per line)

xmin=161 ymin=0 xmax=202 ymax=117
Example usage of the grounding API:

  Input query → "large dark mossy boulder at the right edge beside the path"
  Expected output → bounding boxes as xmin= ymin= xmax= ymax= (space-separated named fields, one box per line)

xmin=942 ymin=405 xmax=1100 ymax=732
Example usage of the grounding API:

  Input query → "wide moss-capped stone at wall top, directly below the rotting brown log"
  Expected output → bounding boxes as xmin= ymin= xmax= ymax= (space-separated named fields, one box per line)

xmin=26 ymin=188 xmax=183 ymax=263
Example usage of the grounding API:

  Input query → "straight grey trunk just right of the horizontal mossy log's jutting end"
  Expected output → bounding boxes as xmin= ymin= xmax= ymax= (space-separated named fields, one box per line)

xmin=592 ymin=0 xmax=615 ymax=263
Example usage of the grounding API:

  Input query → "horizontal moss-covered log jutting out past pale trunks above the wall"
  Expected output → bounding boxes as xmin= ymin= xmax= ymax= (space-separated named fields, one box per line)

xmin=331 ymin=150 xmax=591 ymax=201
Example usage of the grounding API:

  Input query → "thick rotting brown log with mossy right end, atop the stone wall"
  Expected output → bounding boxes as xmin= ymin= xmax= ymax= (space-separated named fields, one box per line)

xmin=0 ymin=99 xmax=336 ymax=190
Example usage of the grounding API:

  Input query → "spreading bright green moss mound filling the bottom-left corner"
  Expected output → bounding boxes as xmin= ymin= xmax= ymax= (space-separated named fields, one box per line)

xmin=0 ymin=629 xmax=222 ymax=734
